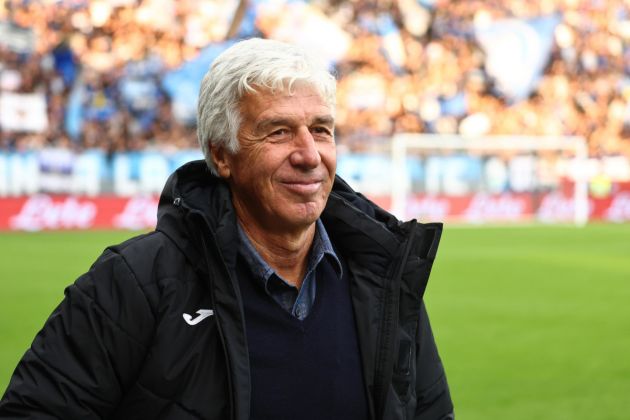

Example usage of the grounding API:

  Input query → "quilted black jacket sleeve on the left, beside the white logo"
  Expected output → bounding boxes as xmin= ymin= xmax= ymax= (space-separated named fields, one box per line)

xmin=0 ymin=251 xmax=154 ymax=419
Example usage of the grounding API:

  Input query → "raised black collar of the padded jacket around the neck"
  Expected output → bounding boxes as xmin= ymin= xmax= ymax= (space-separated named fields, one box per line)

xmin=157 ymin=160 xmax=434 ymax=282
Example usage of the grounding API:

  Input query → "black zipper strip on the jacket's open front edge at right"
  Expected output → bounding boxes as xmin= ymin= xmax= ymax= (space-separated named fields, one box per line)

xmin=374 ymin=221 xmax=417 ymax=419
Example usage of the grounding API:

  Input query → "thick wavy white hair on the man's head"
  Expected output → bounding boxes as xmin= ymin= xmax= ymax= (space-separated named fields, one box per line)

xmin=197 ymin=38 xmax=336 ymax=174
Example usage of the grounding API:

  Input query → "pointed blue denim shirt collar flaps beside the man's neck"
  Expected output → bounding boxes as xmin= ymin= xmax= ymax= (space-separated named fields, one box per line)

xmin=237 ymin=219 xmax=342 ymax=284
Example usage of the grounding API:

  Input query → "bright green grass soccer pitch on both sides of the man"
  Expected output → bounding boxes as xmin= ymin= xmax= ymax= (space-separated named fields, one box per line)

xmin=0 ymin=225 xmax=630 ymax=420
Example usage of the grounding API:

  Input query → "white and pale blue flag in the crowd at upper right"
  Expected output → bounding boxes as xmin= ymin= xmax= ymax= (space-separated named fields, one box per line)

xmin=475 ymin=14 xmax=561 ymax=103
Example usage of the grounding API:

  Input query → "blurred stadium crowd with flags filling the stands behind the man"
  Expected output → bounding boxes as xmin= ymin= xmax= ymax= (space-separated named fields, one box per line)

xmin=0 ymin=0 xmax=630 ymax=156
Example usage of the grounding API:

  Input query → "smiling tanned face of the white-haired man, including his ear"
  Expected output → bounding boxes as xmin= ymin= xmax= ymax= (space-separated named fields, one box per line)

xmin=213 ymin=86 xmax=336 ymax=234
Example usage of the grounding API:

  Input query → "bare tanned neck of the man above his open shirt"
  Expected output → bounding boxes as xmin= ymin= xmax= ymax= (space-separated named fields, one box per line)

xmin=239 ymin=219 xmax=315 ymax=289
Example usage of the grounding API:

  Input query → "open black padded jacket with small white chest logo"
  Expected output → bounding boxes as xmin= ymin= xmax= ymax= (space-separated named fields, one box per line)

xmin=0 ymin=161 xmax=452 ymax=420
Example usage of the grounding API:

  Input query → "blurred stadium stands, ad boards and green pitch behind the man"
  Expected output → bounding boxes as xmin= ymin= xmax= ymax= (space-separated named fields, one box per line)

xmin=0 ymin=0 xmax=630 ymax=419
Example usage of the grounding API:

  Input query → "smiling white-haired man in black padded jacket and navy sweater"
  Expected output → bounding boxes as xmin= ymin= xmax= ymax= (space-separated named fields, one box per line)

xmin=0 ymin=39 xmax=453 ymax=420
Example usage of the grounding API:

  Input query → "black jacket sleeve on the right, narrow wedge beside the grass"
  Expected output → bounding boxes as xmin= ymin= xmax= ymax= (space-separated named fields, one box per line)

xmin=415 ymin=303 xmax=455 ymax=420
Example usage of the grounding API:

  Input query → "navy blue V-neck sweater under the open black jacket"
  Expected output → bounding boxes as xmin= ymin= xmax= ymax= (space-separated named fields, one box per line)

xmin=237 ymin=254 xmax=368 ymax=420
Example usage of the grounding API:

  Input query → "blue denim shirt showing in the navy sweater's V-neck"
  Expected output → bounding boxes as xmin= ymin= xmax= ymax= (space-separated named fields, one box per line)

xmin=238 ymin=219 xmax=342 ymax=320
